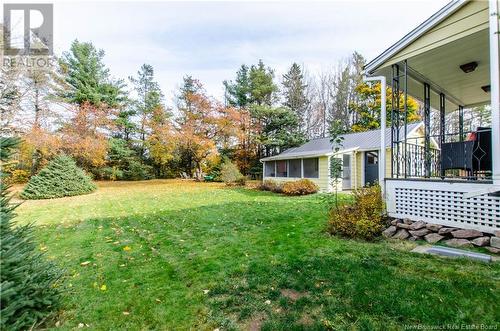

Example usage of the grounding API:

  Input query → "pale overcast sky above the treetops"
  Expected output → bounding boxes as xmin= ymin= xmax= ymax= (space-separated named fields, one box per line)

xmin=50 ymin=0 xmax=447 ymax=105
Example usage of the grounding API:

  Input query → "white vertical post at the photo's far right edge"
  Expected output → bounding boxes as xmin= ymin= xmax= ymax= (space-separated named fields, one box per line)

xmin=489 ymin=0 xmax=500 ymax=185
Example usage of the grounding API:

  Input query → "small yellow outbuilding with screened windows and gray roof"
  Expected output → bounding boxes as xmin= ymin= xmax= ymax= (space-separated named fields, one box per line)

xmin=261 ymin=122 xmax=438 ymax=192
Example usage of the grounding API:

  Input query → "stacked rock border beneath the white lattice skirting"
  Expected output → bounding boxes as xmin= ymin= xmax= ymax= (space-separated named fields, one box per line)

xmin=382 ymin=218 xmax=500 ymax=254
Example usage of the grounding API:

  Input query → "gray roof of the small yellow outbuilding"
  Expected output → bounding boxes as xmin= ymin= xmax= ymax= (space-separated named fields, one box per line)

xmin=261 ymin=122 xmax=423 ymax=161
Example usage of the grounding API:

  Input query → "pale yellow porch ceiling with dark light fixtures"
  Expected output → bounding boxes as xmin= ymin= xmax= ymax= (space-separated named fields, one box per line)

xmin=374 ymin=29 xmax=490 ymax=112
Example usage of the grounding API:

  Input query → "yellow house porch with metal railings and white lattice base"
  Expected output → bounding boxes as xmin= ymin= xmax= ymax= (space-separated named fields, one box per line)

xmin=365 ymin=0 xmax=500 ymax=233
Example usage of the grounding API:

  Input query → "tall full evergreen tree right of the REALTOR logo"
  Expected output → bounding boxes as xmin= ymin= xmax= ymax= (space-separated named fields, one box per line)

xmin=57 ymin=40 xmax=123 ymax=108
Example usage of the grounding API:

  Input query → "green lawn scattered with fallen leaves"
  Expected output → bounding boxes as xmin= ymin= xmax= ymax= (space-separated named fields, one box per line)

xmin=18 ymin=181 xmax=500 ymax=330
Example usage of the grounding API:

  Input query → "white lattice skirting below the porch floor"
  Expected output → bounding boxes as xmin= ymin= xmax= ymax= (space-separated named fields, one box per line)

xmin=386 ymin=180 xmax=500 ymax=233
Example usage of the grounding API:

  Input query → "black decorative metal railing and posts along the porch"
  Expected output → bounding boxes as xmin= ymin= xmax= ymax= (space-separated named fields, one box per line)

xmin=390 ymin=60 xmax=492 ymax=181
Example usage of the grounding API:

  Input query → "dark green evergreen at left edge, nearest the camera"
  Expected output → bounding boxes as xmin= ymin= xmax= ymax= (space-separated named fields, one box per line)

xmin=0 ymin=138 xmax=62 ymax=330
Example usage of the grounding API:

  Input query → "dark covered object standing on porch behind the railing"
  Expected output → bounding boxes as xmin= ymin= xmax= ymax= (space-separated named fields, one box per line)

xmin=441 ymin=127 xmax=491 ymax=174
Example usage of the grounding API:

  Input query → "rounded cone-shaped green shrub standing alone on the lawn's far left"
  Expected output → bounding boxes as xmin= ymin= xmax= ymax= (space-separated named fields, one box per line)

xmin=21 ymin=155 xmax=96 ymax=199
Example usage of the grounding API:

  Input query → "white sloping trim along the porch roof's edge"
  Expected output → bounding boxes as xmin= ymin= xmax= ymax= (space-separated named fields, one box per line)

xmin=365 ymin=0 xmax=468 ymax=75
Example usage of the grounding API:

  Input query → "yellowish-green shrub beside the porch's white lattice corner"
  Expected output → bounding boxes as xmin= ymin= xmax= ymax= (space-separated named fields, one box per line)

xmin=328 ymin=185 xmax=385 ymax=240
